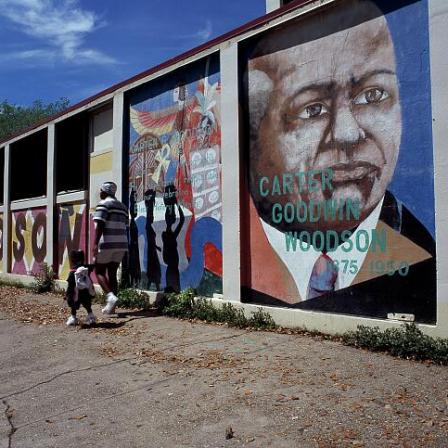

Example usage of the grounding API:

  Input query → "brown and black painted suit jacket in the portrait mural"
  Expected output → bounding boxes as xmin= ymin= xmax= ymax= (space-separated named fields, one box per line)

xmin=242 ymin=192 xmax=436 ymax=323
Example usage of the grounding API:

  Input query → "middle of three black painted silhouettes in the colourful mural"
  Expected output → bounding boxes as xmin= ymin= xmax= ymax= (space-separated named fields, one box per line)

xmin=145 ymin=189 xmax=162 ymax=291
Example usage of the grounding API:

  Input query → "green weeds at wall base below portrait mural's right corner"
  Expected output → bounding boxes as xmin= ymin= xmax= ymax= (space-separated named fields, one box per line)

xmin=342 ymin=323 xmax=448 ymax=365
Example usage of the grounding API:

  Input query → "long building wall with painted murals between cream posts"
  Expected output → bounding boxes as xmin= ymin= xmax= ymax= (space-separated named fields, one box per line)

xmin=3 ymin=0 xmax=448 ymax=336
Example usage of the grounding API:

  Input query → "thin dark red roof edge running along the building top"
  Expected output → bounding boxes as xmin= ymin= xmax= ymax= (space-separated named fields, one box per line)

xmin=0 ymin=0 xmax=314 ymax=145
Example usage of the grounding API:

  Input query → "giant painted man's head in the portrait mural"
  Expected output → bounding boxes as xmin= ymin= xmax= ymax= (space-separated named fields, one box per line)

xmin=247 ymin=0 xmax=401 ymax=230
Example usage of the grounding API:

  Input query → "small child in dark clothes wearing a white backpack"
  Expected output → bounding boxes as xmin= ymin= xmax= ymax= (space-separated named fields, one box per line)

xmin=66 ymin=250 xmax=96 ymax=325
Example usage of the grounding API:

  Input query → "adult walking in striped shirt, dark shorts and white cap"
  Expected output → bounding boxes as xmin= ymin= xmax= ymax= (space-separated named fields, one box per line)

xmin=93 ymin=182 xmax=129 ymax=314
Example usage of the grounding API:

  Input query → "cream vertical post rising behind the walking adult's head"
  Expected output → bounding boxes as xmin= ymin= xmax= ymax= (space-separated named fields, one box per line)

xmin=112 ymin=92 xmax=124 ymax=201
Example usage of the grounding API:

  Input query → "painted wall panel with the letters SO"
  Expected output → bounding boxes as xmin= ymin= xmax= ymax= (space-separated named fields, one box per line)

xmin=11 ymin=207 xmax=47 ymax=275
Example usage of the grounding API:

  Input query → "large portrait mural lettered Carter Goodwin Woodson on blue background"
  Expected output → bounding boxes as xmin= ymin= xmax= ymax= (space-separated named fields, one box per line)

xmin=242 ymin=0 xmax=436 ymax=322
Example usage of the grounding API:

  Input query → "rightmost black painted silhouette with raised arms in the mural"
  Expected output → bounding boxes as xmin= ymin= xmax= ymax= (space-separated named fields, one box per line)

xmin=162 ymin=185 xmax=185 ymax=292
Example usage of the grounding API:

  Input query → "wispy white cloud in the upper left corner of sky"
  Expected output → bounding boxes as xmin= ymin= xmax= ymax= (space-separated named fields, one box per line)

xmin=0 ymin=0 xmax=117 ymax=65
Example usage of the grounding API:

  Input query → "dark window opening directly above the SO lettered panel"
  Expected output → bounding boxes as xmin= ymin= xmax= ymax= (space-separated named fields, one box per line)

xmin=10 ymin=129 xmax=47 ymax=201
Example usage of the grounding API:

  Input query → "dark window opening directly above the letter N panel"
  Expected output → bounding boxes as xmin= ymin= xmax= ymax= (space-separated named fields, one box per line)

xmin=55 ymin=113 xmax=89 ymax=193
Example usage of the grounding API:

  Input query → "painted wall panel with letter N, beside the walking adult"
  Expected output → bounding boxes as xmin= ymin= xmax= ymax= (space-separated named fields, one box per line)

xmin=57 ymin=204 xmax=87 ymax=280
